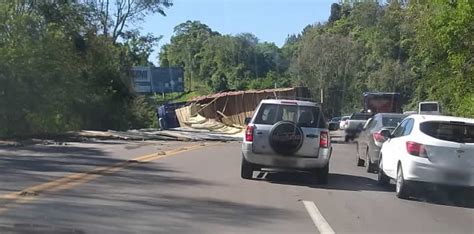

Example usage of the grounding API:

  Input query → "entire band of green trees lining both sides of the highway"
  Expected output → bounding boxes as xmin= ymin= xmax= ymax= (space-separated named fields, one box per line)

xmin=0 ymin=0 xmax=474 ymax=136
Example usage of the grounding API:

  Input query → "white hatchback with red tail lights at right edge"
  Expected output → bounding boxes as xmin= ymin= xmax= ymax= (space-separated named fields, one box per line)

xmin=378 ymin=115 xmax=474 ymax=198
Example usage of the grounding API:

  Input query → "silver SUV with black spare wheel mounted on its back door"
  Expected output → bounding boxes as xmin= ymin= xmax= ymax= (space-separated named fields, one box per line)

xmin=241 ymin=99 xmax=332 ymax=184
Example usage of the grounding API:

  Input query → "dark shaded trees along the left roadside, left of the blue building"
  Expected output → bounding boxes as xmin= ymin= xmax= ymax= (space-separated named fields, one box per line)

xmin=0 ymin=0 xmax=171 ymax=136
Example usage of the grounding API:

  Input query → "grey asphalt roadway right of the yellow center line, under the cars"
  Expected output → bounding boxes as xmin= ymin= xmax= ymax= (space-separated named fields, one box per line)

xmin=0 ymin=142 xmax=474 ymax=233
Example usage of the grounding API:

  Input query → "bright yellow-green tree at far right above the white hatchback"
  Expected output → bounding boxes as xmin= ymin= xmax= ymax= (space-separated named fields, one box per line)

xmin=408 ymin=1 xmax=474 ymax=117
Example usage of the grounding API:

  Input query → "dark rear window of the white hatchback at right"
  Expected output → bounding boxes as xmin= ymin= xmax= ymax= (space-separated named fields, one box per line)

xmin=420 ymin=121 xmax=474 ymax=143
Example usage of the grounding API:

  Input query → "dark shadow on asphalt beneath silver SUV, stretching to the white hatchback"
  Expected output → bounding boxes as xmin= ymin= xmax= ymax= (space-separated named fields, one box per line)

xmin=265 ymin=172 xmax=393 ymax=192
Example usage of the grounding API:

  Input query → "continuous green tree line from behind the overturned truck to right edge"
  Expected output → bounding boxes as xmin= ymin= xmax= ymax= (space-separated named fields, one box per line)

xmin=159 ymin=0 xmax=474 ymax=117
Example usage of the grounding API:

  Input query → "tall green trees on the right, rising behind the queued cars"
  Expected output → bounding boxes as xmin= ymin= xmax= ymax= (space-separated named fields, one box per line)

xmin=292 ymin=0 xmax=474 ymax=117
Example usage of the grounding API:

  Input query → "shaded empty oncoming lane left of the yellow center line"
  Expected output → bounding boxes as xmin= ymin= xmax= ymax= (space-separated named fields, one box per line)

xmin=0 ymin=140 xmax=188 ymax=194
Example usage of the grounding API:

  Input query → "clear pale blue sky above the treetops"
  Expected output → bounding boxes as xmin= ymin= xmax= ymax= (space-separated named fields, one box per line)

xmin=138 ymin=0 xmax=338 ymax=65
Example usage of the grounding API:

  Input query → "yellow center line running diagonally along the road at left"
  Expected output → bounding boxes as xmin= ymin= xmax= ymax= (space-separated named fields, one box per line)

xmin=0 ymin=144 xmax=213 ymax=214
